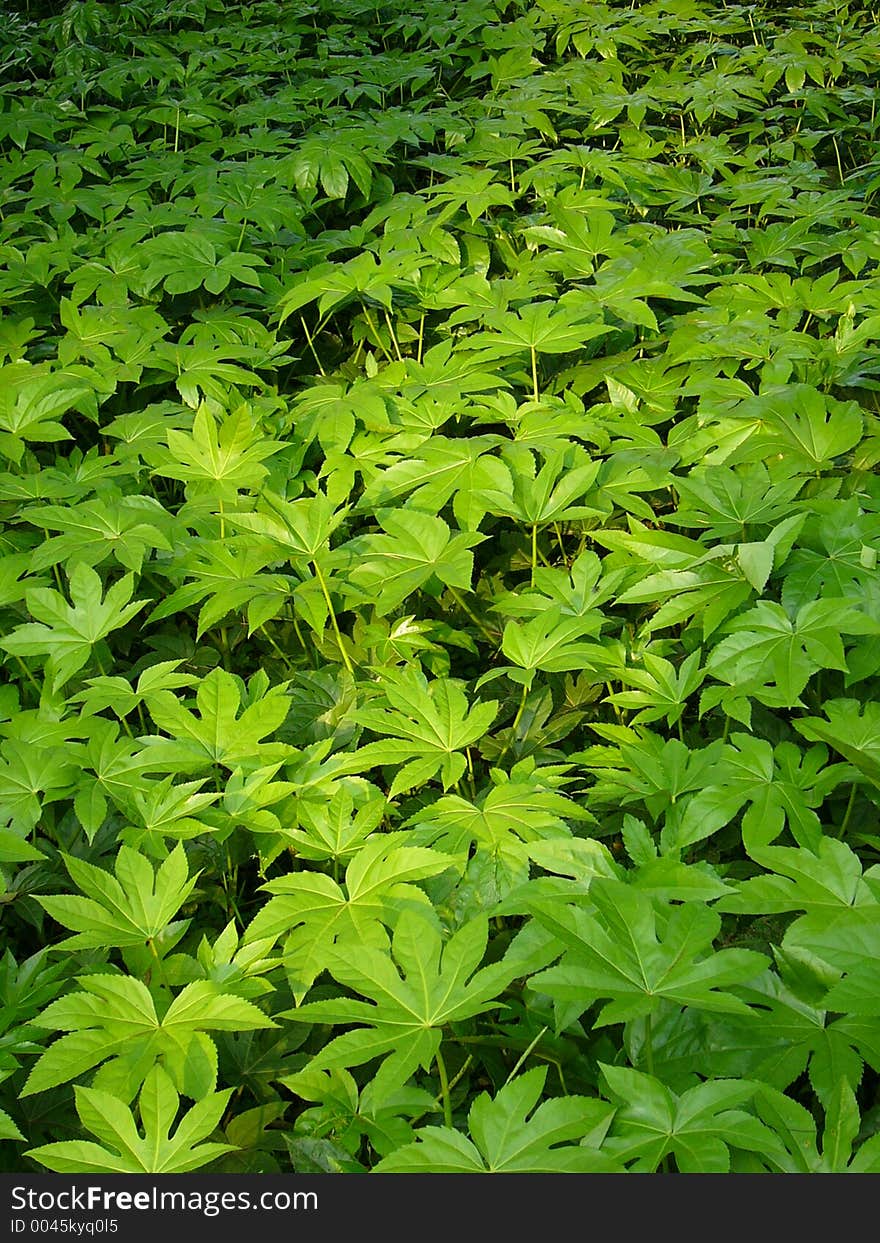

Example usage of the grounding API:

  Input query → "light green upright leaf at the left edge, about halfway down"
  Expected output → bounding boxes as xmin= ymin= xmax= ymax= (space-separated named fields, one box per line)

xmin=0 ymin=562 xmax=148 ymax=690
